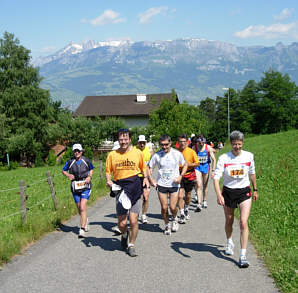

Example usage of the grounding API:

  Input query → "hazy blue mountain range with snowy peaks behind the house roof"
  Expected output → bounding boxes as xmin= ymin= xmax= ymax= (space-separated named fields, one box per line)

xmin=34 ymin=38 xmax=298 ymax=108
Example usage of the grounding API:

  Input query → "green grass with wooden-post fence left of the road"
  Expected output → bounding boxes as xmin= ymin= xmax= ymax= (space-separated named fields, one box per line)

xmin=0 ymin=164 xmax=107 ymax=267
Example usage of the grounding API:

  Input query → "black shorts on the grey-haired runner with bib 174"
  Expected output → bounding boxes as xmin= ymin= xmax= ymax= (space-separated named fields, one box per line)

xmin=222 ymin=186 xmax=251 ymax=209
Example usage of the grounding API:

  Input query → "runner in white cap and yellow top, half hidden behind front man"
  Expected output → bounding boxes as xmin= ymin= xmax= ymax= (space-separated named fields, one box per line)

xmin=136 ymin=135 xmax=153 ymax=224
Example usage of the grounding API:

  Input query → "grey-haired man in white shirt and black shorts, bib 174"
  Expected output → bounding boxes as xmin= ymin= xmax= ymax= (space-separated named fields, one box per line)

xmin=214 ymin=131 xmax=258 ymax=268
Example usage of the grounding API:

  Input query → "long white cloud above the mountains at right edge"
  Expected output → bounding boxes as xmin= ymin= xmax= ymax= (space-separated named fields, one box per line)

xmin=234 ymin=22 xmax=298 ymax=39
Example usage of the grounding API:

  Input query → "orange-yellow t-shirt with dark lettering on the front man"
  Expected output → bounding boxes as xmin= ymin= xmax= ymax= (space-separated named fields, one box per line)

xmin=106 ymin=148 xmax=146 ymax=180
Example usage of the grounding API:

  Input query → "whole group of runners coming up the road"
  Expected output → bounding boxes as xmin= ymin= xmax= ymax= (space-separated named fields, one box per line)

xmin=62 ymin=129 xmax=258 ymax=267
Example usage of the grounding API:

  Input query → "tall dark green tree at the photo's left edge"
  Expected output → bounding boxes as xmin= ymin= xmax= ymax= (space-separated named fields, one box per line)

xmin=0 ymin=32 xmax=57 ymax=162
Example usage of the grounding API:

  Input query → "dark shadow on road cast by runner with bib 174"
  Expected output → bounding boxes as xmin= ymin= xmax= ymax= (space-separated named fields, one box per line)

xmin=171 ymin=242 xmax=238 ymax=266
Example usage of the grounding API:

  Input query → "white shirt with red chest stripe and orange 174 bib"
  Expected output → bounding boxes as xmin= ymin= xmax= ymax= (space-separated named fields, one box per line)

xmin=214 ymin=150 xmax=255 ymax=188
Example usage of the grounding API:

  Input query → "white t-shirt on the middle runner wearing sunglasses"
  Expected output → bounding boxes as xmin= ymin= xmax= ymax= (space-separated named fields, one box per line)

xmin=149 ymin=148 xmax=185 ymax=187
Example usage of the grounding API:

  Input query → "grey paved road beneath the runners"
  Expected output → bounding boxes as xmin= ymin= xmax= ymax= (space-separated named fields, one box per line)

xmin=0 ymin=181 xmax=278 ymax=293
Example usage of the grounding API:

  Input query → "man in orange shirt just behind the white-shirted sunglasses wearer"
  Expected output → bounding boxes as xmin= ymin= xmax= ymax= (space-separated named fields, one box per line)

xmin=178 ymin=134 xmax=200 ymax=224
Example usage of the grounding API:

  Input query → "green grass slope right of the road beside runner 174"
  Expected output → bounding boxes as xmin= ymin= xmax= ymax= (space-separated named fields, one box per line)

xmin=221 ymin=130 xmax=298 ymax=293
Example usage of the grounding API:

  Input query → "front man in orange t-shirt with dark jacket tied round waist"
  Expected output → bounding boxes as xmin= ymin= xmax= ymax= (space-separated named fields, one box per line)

xmin=106 ymin=129 xmax=149 ymax=257
